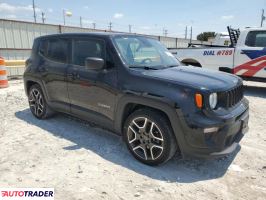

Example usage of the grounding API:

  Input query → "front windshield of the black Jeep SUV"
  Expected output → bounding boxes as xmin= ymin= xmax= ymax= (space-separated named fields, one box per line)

xmin=114 ymin=36 xmax=180 ymax=69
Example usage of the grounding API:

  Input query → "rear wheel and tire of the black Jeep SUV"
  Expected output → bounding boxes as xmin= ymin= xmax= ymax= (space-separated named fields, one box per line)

xmin=28 ymin=84 xmax=54 ymax=119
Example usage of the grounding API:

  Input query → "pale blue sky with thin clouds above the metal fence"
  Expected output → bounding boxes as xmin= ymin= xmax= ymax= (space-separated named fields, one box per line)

xmin=0 ymin=0 xmax=266 ymax=37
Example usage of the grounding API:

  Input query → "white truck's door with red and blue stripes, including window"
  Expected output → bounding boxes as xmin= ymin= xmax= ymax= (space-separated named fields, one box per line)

xmin=234 ymin=30 xmax=266 ymax=78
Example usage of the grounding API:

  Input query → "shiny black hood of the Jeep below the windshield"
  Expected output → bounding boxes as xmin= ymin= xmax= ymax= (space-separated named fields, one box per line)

xmin=142 ymin=66 xmax=241 ymax=91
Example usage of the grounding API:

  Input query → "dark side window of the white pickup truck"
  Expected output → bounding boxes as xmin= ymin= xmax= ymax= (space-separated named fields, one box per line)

xmin=245 ymin=31 xmax=266 ymax=47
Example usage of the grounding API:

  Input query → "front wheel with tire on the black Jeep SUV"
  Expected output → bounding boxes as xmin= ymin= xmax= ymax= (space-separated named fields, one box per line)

xmin=123 ymin=109 xmax=177 ymax=166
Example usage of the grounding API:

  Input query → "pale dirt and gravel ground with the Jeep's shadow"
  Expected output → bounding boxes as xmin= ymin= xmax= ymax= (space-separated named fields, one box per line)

xmin=0 ymin=80 xmax=266 ymax=200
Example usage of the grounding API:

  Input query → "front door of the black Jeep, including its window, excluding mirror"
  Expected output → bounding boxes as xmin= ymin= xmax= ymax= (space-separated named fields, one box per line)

xmin=67 ymin=38 xmax=118 ymax=126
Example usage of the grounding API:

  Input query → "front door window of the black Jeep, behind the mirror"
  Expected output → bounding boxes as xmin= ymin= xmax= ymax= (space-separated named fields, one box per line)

xmin=72 ymin=39 xmax=105 ymax=66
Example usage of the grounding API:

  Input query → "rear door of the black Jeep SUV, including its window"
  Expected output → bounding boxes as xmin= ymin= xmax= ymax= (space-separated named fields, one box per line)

xmin=38 ymin=37 xmax=70 ymax=111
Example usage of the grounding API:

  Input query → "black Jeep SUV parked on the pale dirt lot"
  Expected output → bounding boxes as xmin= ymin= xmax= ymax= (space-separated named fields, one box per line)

xmin=24 ymin=33 xmax=249 ymax=165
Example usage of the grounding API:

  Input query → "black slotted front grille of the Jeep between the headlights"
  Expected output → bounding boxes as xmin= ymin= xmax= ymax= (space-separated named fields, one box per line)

xmin=218 ymin=85 xmax=243 ymax=108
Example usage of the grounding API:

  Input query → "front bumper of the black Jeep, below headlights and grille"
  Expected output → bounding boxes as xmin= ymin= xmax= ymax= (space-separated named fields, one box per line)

xmin=179 ymin=99 xmax=249 ymax=158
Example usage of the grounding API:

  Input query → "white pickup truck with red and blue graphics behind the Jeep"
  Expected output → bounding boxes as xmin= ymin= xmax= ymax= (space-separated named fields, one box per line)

xmin=170 ymin=27 xmax=266 ymax=82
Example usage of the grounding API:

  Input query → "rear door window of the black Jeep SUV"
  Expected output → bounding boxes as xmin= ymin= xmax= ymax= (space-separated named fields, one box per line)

xmin=39 ymin=39 xmax=68 ymax=63
